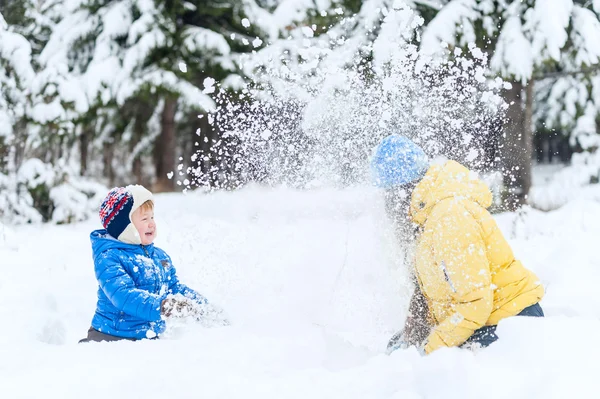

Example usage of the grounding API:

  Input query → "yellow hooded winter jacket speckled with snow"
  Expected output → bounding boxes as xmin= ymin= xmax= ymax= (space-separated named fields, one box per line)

xmin=410 ymin=161 xmax=544 ymax=353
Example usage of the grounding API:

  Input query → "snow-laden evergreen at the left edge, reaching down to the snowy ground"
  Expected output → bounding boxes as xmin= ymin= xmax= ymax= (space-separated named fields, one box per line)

xmin=0 ymin=3 xmax=104 ymax=223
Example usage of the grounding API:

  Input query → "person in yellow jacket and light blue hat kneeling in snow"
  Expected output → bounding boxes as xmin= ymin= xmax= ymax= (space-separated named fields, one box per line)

xmin=371 ymin=135 xmax=544 ymax=354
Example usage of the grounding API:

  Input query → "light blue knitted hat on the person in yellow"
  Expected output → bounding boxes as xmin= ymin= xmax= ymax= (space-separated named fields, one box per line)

xmin=371 ymin=134 xmax=429 ymax=188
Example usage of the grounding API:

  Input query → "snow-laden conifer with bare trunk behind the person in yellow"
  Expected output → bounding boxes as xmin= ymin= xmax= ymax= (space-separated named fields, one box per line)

xmin=422 ymin=0 xmax=600 ymax=209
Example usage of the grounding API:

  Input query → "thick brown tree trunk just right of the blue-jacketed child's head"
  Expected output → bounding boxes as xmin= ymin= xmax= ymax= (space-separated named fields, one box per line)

xmin=154 ymin=96 xmax=178 ymax=192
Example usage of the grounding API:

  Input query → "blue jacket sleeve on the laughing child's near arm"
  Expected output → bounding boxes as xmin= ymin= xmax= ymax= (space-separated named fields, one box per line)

xmin=95 ymin=256 xmax=164 ymax=321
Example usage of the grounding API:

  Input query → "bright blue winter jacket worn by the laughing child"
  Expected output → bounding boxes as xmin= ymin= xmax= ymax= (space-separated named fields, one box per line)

xmin=90 ymin=230 xmax=207 ymax=339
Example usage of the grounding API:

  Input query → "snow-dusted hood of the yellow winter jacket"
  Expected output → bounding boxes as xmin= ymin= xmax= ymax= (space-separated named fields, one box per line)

xmin=410 ymin=161 xmax=492 ymax=224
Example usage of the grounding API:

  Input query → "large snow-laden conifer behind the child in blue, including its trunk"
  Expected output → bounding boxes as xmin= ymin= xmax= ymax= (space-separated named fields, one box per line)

xmin=34 ymin=0 xmax=268 ymax=190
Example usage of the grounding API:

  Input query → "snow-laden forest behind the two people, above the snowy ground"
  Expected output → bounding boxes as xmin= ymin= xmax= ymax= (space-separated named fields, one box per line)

xmin=0 ymin=0 xmax=600 ymax=224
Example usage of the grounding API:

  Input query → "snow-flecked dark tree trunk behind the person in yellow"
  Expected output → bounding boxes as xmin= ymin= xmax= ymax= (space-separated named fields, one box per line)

xmin=500 ymin=81 xmax=533 ymax=210
